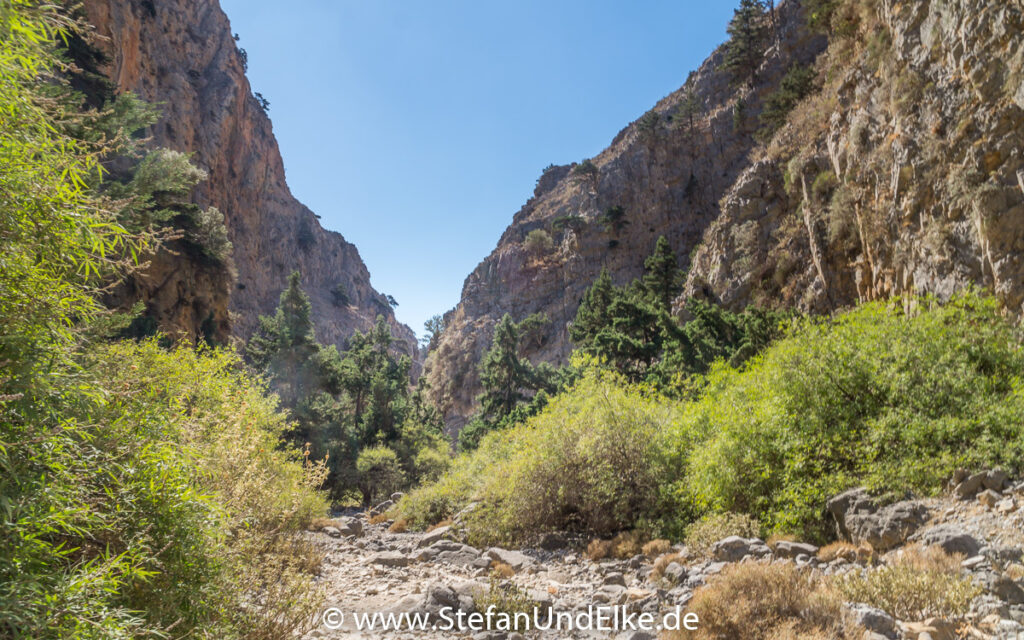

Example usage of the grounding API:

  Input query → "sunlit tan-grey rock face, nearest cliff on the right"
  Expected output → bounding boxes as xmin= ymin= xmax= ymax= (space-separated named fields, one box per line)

xmin=677 ymin=0 xmax=1024 ymax=312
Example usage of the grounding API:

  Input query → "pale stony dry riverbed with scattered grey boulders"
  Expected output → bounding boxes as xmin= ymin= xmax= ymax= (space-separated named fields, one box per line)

xmin=306 ymin=472 xmax=1024 ymax=640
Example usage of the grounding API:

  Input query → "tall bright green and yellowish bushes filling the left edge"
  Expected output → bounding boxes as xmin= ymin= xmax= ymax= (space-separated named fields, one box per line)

xmin=0 ymin=0 xmax=325 ymax=640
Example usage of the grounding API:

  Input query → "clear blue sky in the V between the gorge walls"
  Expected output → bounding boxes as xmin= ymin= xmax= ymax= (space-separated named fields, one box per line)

xmin=221 ymin=0 xmax=738 ymax=335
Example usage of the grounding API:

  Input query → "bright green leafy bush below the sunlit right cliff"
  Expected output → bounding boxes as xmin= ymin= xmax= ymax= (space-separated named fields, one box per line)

xmin=677 ymin=296 xmax=1024 ymax=540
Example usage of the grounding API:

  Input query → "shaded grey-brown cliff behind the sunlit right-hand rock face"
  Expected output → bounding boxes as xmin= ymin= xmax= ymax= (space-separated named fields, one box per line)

xmin=427 ymin=2 xmax=826 ymax=429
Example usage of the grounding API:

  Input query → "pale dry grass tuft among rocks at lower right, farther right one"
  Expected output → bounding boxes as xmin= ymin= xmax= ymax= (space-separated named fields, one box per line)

xmin=836 ymin=546 xmax=981 ymax=620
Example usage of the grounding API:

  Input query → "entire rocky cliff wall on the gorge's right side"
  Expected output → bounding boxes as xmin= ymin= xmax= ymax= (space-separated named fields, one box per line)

xmin=428 ymin=0 xmax=1024 ymax=428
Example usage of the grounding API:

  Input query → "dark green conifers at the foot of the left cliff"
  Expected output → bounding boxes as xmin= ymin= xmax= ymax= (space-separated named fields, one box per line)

xmin=246 ymin=272 xmax=446 ymax=501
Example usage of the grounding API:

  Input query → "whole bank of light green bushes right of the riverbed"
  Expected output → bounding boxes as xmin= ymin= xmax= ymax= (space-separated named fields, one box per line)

xmin=402 ymin=295 xmax=1024 ymax=542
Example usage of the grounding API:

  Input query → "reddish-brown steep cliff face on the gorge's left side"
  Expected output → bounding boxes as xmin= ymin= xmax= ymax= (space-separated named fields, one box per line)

xmin=84 ymin=0 xmax=416 ymax=355
